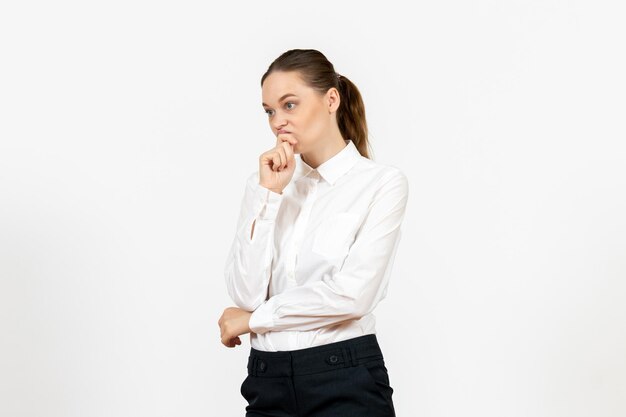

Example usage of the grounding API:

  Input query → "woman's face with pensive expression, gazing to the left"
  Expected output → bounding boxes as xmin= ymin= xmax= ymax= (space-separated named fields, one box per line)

xmin=262 ymin=71 xmax=339 ymax=153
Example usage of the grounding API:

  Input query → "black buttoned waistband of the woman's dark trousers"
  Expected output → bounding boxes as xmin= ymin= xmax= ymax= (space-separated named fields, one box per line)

xmin=248 ymin=333 xmax=383 ymax=377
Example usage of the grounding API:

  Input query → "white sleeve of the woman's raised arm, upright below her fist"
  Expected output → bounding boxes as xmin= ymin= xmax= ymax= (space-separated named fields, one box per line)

xmin=224 ymin=172 xmax=283 ymax=311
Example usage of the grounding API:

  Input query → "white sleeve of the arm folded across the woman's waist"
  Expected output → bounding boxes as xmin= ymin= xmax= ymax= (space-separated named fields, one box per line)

xmin=249 ymin=170 xmax=409 ymax=334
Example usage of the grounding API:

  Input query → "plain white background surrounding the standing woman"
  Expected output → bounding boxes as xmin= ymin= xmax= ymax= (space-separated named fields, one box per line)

xmin=0 ymin=0 xmax=626 ymax=417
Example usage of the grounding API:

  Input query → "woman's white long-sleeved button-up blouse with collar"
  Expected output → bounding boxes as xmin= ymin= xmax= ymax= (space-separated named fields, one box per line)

xmin=224 ymin=140 xmax=408 ymax=351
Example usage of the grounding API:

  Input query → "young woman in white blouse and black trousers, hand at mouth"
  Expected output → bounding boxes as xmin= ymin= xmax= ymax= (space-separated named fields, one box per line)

xmin=218 ymin=49 xmax=408 ymax=417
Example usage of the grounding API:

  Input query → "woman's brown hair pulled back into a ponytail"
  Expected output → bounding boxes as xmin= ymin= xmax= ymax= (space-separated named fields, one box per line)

xmin=261 ymin=49 xmax=370 ymax=158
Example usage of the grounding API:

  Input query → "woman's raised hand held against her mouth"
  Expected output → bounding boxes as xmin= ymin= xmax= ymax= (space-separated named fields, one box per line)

xmin=259 ymin=134 xmax=298 ymax=194
